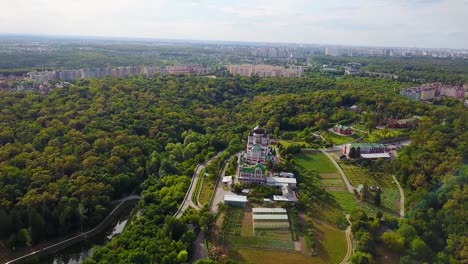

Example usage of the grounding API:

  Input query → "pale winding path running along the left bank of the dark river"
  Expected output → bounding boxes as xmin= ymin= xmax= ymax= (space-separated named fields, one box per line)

xmin=5 ymin=195 xmax=140 ymax=264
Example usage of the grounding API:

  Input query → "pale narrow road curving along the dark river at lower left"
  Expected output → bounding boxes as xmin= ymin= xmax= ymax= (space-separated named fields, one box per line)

xmin=5 ymin=195 xmax=140 ymax=264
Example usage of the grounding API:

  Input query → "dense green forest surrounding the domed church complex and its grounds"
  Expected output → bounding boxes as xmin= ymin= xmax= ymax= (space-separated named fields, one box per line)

xmin=0 ymin=76 xmax=468 ymax=263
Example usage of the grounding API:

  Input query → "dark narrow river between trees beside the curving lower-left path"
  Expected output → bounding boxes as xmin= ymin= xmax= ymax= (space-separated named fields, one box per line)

xmin=39 ymin=201 xmax=137 ymax=264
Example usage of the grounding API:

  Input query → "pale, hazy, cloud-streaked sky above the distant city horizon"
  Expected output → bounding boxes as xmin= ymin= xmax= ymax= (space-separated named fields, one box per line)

xmin=0 ymin=0 xmax=468 ymax=49
